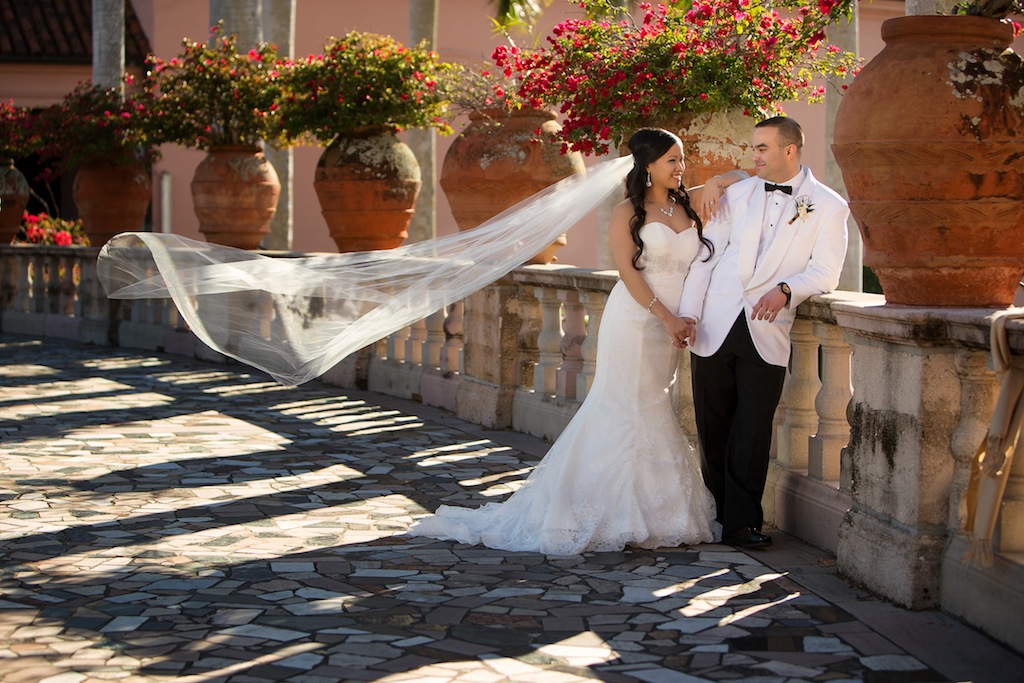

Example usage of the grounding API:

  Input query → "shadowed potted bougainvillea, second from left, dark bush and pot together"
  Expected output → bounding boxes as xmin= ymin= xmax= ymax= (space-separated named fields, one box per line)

xmin=33 ymin=79 xmax=159 ymax=246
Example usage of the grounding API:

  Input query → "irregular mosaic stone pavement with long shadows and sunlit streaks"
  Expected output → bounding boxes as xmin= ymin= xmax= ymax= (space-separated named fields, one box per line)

xmin=0 ymin=335 xmax=1024 ymax=683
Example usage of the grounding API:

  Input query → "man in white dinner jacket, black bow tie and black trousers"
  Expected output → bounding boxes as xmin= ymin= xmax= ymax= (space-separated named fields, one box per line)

xmin=679 ymin=117 xmax=849 ymax=548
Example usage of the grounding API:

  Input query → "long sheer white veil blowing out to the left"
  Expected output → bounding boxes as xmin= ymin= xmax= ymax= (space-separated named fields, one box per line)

xmin=97 ymin=156 xmax=633 ymax=385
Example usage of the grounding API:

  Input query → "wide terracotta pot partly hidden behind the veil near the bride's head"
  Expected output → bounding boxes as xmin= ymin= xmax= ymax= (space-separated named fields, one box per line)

xmin=440 ymin=110 xmax=587 ymax=263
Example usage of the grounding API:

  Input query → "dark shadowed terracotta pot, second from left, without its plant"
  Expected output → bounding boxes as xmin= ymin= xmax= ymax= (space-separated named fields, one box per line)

xmin=71 ymin=161 xmax=153 ymax=247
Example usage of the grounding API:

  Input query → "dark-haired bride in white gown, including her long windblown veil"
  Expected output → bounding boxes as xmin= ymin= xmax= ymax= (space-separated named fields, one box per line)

xmin=97 ymin=129 xmax=746 ymax=554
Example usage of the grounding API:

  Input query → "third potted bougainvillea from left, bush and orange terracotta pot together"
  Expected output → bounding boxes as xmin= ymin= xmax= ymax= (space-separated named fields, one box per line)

xmin=145 ymin=23 xmax=281 ymax=249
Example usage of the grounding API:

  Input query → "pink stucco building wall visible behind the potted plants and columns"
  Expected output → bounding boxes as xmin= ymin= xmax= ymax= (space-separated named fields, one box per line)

xmin=0 ymin=0 xmax=1007 ymax=267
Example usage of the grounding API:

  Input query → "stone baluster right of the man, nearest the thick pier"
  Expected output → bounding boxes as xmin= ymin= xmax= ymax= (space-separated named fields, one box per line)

xmin=807 ymin=323 xmax=853 ymax=481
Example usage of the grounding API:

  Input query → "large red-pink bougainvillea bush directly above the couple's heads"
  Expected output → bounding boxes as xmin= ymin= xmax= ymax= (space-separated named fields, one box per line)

xmin=493 ymin=0 xmax=856 ymax=154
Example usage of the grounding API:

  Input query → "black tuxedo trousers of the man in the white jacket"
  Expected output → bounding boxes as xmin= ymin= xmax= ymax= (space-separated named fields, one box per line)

xmin=690 ymin=312 xmax=785 ymax=533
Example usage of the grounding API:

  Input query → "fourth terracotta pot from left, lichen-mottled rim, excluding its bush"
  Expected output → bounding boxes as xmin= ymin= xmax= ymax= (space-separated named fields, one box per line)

xmin=313 ymin=128 xmax=422 ymax=252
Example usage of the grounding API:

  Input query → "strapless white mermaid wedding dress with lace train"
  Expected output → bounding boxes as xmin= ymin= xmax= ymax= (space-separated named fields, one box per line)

xmin=409 ymin=223 xmax=721 ymax=555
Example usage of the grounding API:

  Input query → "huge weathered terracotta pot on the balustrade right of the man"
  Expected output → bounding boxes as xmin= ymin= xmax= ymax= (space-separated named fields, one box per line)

xmin=833 ymin=16 xmax=1024 ymax=307
